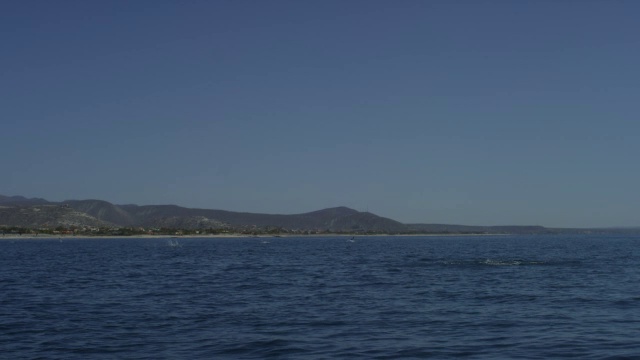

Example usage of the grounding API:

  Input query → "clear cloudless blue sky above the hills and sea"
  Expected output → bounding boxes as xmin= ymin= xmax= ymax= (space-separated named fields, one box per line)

xmin=0 ymin=0 xmax=640 ymax=227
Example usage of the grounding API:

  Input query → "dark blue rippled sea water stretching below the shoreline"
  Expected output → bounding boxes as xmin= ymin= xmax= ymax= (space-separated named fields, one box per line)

xmin=0 ymin=236 xmax=640 ymax=359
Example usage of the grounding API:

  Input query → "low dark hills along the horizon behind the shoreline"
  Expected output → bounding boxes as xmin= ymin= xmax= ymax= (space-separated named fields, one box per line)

xmin=0 ymin=195 xmax=638 ymax=234
